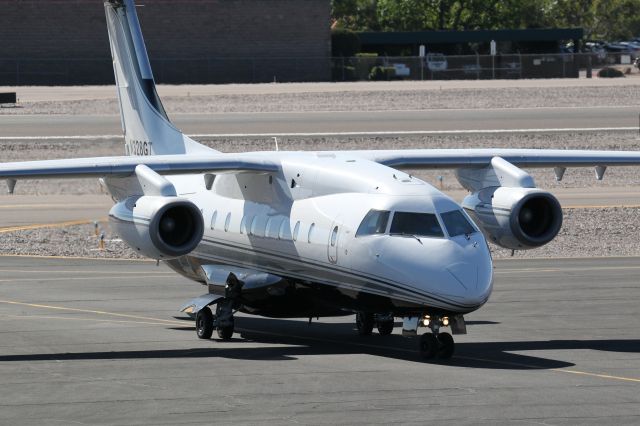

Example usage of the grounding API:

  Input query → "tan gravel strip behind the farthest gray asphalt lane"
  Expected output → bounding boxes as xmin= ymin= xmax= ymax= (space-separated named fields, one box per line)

xmin=0 ymin=84 xmax=640 ymax=115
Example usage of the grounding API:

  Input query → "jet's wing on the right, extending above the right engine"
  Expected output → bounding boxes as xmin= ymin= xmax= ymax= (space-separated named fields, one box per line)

xmin=349 ymin=149 xmax=640 ymax=169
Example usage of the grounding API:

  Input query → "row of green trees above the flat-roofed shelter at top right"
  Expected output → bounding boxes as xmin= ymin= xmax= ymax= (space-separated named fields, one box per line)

xmin=332 ymin=0 xmax=640 ymax=41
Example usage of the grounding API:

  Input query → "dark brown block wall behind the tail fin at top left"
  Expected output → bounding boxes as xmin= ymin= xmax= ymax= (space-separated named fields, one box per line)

xmin=0 ymin=0 xmax=331 ymax=84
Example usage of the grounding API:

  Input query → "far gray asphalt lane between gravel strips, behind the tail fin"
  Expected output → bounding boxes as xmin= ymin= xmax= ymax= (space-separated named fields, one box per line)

xmin=0 ymin=106 xmax=638 ymax=138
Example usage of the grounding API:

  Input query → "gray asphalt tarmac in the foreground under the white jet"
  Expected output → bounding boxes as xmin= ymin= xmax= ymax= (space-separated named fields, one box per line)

xmin=0 ymin=257 xmax=640 ymax=425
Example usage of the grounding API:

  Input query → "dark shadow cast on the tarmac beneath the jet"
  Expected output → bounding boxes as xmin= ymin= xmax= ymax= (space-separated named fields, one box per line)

xmin=0 ymin=317 xmax=640 ymax=370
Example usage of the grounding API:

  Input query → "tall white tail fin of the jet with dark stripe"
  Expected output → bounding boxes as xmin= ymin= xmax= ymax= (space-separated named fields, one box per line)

xmin=104 ymin=0 xmax=215 ymax=155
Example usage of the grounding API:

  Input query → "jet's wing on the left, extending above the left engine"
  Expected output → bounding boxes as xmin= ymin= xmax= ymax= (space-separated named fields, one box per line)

xmin=0 ymin=154 xmax=280 ymax=181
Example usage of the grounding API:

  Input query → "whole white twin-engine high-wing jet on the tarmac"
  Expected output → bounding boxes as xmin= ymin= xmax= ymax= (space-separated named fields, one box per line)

xmin=0 ymin=0 xmax=640 ymax=359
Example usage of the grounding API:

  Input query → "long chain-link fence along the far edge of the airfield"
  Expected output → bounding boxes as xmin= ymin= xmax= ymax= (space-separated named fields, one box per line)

xmin=0 ymin=52 xmax=635 ymax=86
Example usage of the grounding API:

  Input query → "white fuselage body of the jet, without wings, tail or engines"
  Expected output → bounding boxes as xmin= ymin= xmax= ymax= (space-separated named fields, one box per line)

xmin=155 ymin=152 xmax=493 ymax=313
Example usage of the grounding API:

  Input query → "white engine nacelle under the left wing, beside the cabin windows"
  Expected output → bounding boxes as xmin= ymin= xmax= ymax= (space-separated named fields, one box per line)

xmin=109 ymin=196 xmax=204 ymax=259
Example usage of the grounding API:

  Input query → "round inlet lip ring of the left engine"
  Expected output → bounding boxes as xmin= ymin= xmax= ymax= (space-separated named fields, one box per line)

xmin=149 ymin=201 xmax=204 ymax=257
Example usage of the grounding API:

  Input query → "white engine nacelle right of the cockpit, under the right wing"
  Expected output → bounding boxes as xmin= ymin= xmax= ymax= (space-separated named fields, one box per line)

xmin=462 ymin=187 xmax=562 ymax=250
